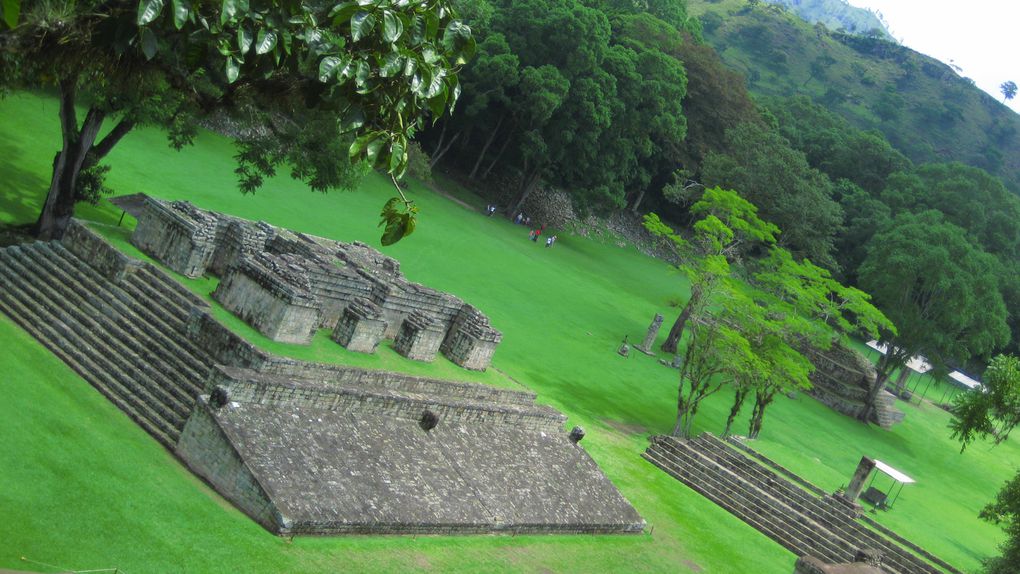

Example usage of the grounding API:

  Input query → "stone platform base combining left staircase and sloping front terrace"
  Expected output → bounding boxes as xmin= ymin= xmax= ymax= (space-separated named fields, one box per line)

xmin=0 ymin=220 xmax=645 ymax=534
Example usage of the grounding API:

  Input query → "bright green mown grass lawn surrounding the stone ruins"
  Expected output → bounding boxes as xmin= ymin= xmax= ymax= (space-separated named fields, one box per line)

xmin=0 ymin=95 xmax=1020 ymax=574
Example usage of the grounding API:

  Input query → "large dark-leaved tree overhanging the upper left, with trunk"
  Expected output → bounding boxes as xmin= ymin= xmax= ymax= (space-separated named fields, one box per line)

xmin=0 ymin=0 xmax=474 ymax=239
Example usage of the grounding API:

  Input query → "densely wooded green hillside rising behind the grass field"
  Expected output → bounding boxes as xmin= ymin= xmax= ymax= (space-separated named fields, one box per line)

xmin=436 ymin=0 xmax=1020 ymax=364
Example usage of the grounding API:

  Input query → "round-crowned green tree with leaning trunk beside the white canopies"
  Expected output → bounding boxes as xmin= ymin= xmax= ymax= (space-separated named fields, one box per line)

xmin=860 ymin=211 xmax=1010 ymax=421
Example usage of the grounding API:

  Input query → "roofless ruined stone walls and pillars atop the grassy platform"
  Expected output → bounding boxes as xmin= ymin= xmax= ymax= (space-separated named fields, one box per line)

xmin=132 ymin=198 xmax=503 ymax=371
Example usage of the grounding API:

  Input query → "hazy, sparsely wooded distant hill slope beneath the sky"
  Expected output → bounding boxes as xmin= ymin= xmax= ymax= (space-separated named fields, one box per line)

xmin=689 ymin=0 xmax=1020 ymax=194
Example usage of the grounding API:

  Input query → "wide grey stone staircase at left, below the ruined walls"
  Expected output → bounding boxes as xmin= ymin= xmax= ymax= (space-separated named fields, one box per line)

xmin=0 ymin=243 xmax=212 ymax=449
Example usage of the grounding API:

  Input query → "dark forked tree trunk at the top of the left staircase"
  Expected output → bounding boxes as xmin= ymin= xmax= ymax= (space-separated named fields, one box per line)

xmin=35 ymin=80 xmax=106 ymax=241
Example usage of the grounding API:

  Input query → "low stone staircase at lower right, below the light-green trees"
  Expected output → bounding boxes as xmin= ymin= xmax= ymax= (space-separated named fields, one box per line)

xmin=643 ymin=433 xmax=958 ymax=574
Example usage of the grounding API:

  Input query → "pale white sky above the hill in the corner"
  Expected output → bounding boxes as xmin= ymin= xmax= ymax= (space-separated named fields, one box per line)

xmin=848 ymin=0 xmax=1020 ymax=112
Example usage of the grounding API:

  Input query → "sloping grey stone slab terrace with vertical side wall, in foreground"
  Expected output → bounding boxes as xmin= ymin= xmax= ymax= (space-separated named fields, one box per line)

xmin=177 ymin=368 xmax=644 ymax=534
